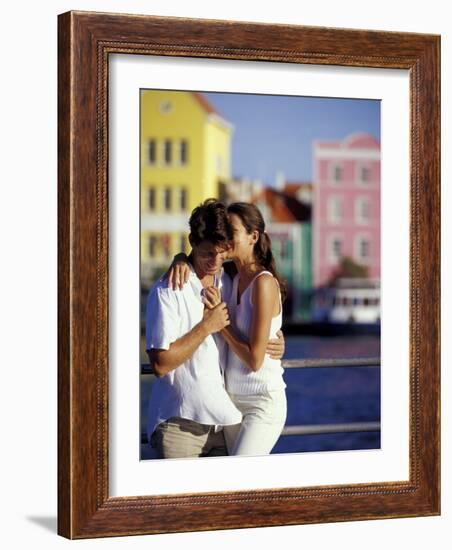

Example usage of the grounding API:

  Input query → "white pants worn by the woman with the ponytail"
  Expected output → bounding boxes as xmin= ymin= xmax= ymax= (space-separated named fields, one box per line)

xmin=223 ymin=390 xmax=287 ymax=456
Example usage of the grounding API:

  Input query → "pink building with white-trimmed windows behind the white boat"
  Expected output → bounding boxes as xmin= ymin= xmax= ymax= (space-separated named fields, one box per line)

xmin=312 ymin=134 xmax=380 ymax=288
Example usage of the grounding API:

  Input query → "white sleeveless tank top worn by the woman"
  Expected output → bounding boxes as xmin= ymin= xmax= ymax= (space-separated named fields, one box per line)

xmin=225 ymin=271 xmax=286 ymax=395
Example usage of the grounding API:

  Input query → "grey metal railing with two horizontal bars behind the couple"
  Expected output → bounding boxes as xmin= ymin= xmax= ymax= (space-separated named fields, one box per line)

xmin=141 ymin=357 xmax=381 ymax=443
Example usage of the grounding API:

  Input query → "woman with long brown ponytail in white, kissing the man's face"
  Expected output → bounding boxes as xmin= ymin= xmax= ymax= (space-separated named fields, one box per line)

xmin=169 ymin=202 xmax=287 ymax=455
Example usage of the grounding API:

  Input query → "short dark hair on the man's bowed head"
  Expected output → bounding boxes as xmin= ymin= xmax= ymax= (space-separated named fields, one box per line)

xmin=189 ymin=199 xmax=232 ymax=247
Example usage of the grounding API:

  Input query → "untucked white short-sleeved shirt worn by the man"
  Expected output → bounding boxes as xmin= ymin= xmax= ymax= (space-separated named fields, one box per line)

xmin=146 ymin=266 xmax=242 ymax=438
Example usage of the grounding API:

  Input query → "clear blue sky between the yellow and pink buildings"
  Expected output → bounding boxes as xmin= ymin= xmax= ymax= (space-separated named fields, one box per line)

xmin=204 ymin=92 xmax=380 ymax=185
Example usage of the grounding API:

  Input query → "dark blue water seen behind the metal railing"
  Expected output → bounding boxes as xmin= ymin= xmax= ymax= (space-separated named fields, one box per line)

xmin=141 ymin=335 xmax=380 ymax=459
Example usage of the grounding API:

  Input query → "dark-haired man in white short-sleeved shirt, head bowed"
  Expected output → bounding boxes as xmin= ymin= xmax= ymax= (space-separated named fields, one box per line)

xmin=146 ymin=199 xmax=282 ymax=458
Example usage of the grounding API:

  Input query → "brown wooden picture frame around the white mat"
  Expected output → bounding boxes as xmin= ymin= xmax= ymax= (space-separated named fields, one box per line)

xmin=58 ymin=12 xmax=440 ymax=538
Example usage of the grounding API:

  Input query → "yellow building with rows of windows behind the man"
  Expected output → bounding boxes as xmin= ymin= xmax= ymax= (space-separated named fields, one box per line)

xmin=141 ymin=90 xmax=232 ymax=284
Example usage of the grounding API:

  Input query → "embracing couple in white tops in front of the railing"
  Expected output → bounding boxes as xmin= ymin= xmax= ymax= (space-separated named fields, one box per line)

xmin=146 ymin=199 xmax=287 ymax=458
